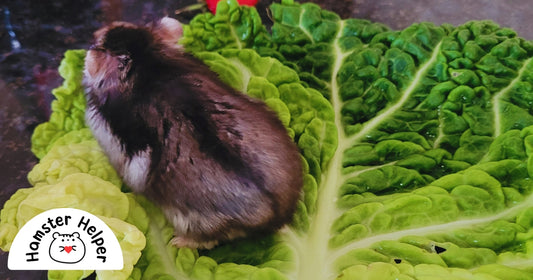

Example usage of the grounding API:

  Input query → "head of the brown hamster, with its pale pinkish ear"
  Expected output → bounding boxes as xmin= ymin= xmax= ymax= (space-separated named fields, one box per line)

xmin=83 ymin=17 xmax=182 ymax=104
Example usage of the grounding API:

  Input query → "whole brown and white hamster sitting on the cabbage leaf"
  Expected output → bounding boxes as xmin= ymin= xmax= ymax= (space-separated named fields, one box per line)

xmin=84 ymin=18 xmax=303 ymax=248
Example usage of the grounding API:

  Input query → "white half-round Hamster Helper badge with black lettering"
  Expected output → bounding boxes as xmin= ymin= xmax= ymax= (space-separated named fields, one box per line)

xmin=7 ymin=208 xmax=124 ymax=270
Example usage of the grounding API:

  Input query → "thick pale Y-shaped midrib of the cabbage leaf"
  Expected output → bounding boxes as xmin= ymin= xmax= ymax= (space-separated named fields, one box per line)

xmin=291 ymin=24 xmax=441 ymax=279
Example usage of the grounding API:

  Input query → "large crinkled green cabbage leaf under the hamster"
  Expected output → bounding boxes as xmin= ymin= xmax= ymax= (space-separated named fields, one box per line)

xmin=5 ymin=0 xmax=533 ymax=279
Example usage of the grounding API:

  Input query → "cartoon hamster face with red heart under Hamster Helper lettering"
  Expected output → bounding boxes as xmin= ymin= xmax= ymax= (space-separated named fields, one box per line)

xmin=49 ymin=232 xmax=85 ymax=263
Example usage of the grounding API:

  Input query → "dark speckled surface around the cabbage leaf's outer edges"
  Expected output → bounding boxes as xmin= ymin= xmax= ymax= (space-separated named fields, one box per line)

xmin=0 ymin=0 xmax=533 ymax=280
